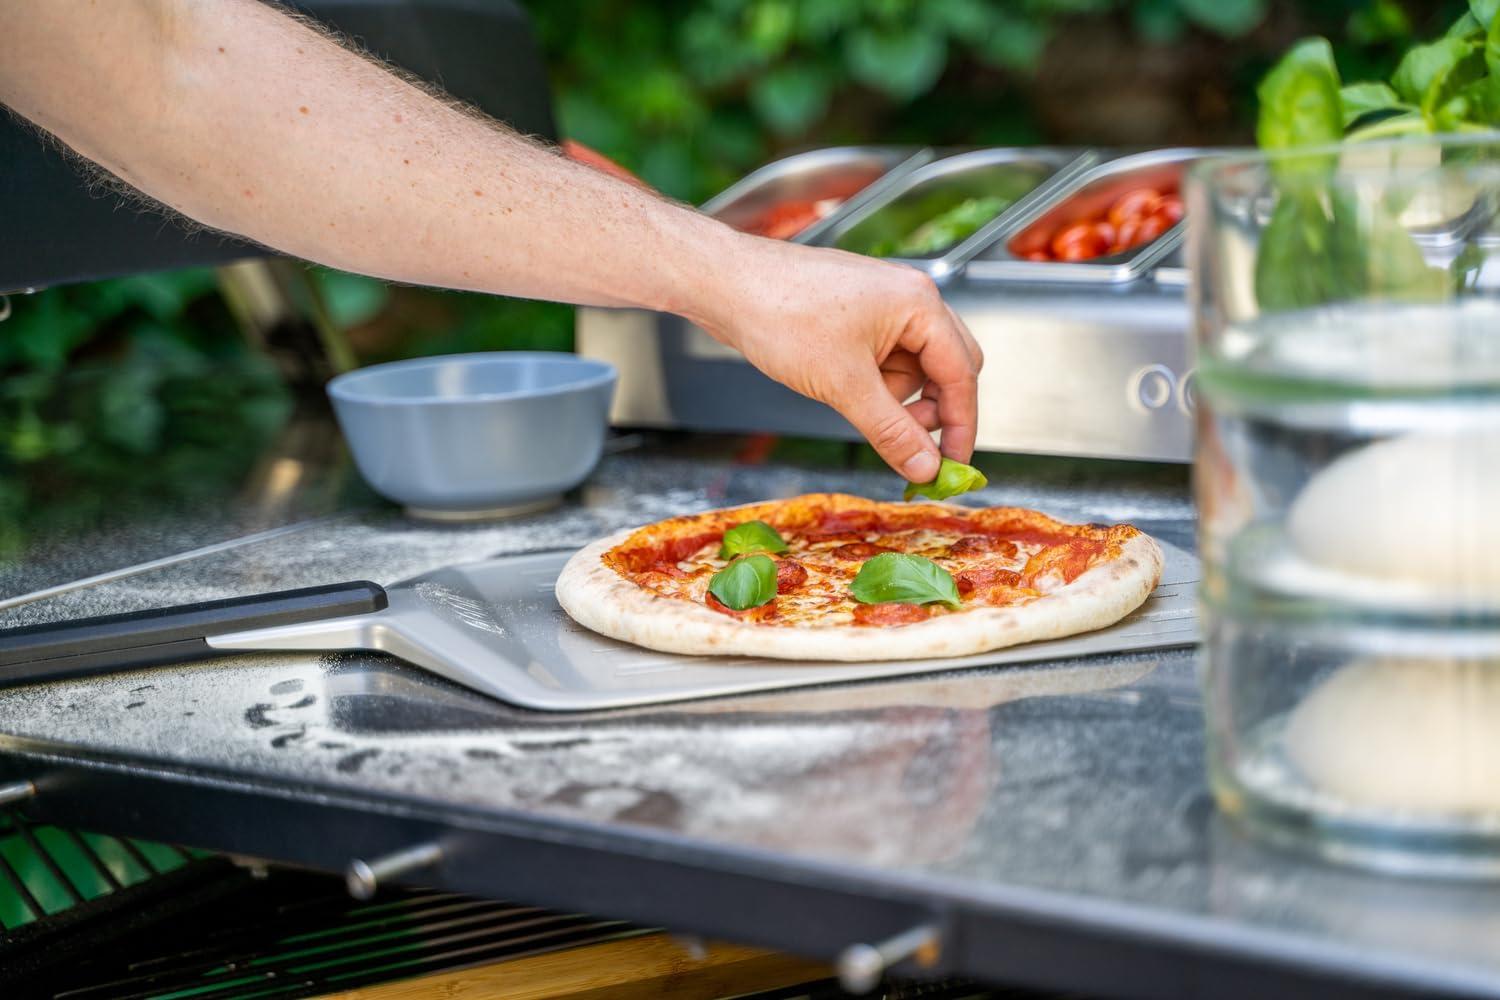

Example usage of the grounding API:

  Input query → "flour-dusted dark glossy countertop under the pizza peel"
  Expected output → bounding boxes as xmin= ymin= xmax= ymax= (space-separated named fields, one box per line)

xmin=0 ymin=434 xmax=1500 ymax=996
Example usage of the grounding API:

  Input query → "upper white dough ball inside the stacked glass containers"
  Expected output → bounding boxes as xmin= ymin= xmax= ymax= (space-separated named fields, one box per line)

xmin=1287 ymin=429 xmax=1500 ymax=594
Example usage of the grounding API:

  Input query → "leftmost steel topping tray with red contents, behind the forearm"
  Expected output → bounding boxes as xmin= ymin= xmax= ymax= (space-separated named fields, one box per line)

xmin=702 ymin=145 xmax=933 ymax=243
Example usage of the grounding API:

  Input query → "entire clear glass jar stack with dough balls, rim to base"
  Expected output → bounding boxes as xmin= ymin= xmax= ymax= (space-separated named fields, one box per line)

xmin=1187 ymin=136 xmax=1500 ymax=876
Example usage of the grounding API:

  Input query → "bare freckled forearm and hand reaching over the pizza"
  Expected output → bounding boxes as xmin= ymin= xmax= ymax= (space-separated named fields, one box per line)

xmin=0 ymin=0 xmax=983 ymax=481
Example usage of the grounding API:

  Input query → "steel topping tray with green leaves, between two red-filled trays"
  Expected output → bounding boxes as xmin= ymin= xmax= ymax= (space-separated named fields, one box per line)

xmin=815 ymin=148 xmax=1095 ymax=276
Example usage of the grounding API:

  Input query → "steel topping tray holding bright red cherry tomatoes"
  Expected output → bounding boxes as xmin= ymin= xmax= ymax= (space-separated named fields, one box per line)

xmin=954 ymin=148 xmax=1215 ymax=283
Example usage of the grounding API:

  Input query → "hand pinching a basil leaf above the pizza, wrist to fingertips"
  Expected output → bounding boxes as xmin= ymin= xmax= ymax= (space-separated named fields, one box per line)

xmin=684 ymin=234 xmax=984 ymax=483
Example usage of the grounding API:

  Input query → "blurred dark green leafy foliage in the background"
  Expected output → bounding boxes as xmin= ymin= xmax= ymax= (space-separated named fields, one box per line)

xmin=0 ymin=0 xmax=1464 ymax=559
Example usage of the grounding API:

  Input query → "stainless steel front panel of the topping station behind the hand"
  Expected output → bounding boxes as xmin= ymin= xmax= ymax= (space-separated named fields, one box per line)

xmin=578 ymin=277 xmax=1193 ymax=462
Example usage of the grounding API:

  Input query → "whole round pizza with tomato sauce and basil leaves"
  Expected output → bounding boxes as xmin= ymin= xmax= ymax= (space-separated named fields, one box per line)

xmin=557 ymin=493 xmax=1163 ymax=661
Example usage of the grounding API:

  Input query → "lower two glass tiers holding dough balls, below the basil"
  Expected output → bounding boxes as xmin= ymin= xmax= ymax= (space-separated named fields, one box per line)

xmin=1196 ymin=298 xmax=1500 ymax=874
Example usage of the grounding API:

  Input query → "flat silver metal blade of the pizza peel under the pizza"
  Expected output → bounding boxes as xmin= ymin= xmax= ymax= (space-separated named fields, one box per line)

xmin=322 ymin=543 xmax=1199 ymax=712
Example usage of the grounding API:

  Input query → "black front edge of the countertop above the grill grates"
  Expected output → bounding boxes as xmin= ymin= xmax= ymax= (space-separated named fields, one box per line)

xmin=0 ymin=741 xmax=1485 ymax=1000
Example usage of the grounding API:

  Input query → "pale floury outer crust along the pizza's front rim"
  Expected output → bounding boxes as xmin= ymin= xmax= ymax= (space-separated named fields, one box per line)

xmin=557 ymin=500 xmax=1163 ymax=663
